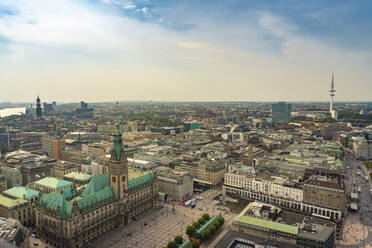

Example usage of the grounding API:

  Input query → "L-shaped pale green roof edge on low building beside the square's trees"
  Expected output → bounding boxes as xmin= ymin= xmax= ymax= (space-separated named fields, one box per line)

xmin=235 ymin=203 xmax=298 ymax=235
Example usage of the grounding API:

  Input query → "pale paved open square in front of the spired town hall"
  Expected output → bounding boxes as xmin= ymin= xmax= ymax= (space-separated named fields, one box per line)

xmin=93 ymin=189 xmax=235 ymax=248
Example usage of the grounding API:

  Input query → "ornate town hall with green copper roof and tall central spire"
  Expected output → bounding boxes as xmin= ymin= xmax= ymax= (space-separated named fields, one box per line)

xmin=35 ymin=119 xmax=158 ymax=247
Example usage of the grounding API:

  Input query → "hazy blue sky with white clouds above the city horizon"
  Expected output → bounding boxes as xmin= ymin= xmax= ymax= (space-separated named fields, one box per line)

xmin=0 ymin=0 xmax=372 ymax=102
